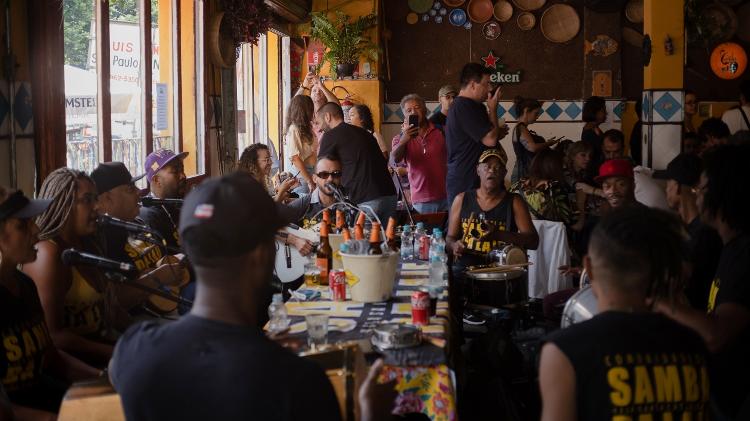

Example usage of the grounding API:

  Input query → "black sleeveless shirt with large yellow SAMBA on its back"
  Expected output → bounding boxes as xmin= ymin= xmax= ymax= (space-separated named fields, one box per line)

xmin=546 ymin=311 xmax=710 ymax=421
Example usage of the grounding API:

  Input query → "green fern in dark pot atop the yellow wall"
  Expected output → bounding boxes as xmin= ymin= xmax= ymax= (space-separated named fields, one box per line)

xmin=311 ymin=11 xmax=378 ymax=78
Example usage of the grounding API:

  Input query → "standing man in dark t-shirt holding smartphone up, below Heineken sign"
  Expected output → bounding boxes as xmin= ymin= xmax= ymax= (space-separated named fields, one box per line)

xmin=445 ymin=63 xmax=508 ymax=203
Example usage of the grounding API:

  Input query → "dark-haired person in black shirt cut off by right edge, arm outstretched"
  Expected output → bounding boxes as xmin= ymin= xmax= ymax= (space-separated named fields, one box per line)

xmin=656 ymin=145 xmax=750 ymax=420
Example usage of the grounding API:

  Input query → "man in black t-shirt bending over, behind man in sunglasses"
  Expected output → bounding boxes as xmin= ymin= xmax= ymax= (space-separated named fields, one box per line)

xmin=315 ymin=102 xmax=396 ymax=223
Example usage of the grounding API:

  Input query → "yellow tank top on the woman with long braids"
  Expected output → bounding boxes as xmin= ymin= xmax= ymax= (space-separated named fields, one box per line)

xmin=63 ymin=267 xmax=104 ymax=335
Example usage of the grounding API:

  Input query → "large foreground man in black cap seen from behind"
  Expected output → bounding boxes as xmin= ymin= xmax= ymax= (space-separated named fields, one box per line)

xmin=110 ymin=172 xmax=341 ymax=421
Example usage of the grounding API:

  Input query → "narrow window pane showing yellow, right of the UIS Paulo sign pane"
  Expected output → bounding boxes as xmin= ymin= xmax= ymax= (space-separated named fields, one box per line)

xmin=151 ymin=0 xmax=179 ymax=151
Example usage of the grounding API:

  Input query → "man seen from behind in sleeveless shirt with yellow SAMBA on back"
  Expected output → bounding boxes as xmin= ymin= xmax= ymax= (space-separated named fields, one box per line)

xmin=539 ymin=206 xmax=710 ymax=421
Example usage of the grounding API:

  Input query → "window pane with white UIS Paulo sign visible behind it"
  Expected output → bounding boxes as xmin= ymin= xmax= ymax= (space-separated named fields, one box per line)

xmin=109 ymin=0 xmax=145 ymax=187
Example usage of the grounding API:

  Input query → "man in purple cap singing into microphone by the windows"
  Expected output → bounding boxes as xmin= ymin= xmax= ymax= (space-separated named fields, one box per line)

xmin=140 ymin=149 xmax=188 ymax=250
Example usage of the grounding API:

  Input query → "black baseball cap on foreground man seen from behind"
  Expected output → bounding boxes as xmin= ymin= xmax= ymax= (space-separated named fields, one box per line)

xmin=180 ymin=172 xmax=284 ymax=266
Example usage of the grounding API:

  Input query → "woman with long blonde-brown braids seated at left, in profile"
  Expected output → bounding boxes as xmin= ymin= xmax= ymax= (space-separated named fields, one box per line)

xmin=23 ymin=168 xmax=113 ymax=366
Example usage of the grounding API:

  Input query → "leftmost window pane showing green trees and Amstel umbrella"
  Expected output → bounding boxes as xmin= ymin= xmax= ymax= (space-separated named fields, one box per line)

xmin=63 ymin=0 xmax=99 ymax=172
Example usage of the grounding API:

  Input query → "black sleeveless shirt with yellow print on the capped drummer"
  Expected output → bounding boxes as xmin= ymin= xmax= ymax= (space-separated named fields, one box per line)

xmin=458 ymin=190 xmax=518 ymax=266
